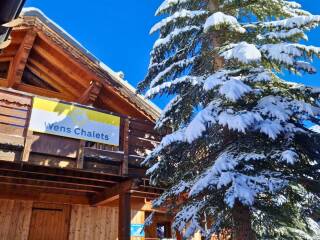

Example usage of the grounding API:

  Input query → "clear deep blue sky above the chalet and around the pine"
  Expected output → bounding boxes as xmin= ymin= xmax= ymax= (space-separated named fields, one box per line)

xmin=26 ymin=0 xmax=320 ymax=107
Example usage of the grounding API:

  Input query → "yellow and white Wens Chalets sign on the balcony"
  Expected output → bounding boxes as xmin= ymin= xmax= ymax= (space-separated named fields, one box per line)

xmin=29 ymin=97 xmax=120 ymax=146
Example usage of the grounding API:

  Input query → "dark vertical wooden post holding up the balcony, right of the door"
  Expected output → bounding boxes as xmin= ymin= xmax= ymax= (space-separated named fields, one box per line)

xmin=118 ymin=192 xmax=131 ymax=240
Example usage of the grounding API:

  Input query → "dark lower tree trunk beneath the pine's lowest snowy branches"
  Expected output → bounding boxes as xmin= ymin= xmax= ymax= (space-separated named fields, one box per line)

xmin=232 ymin=201 xmax=256 ymax=240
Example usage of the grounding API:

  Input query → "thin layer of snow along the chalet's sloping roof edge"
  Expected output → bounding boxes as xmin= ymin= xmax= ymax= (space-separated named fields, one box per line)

xmin=21 ymin=7 xmax=161 ymax=119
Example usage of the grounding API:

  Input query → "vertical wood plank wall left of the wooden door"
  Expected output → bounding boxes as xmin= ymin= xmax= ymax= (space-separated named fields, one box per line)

xmin=0 ymin=200 xmax=32 ymax=240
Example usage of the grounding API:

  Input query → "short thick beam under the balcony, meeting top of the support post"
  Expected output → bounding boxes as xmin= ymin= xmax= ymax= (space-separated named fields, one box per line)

xmin=90 ymin=180 xmax=134 ymax=206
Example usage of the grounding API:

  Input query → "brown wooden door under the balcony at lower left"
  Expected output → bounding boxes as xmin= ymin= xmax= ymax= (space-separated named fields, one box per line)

xmin=28 ymin=203 xmax=70 ymax=240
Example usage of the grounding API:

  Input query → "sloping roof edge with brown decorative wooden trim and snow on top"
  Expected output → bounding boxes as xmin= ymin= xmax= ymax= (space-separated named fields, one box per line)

xmin=17 ymin=8 xmax=161 ymax=121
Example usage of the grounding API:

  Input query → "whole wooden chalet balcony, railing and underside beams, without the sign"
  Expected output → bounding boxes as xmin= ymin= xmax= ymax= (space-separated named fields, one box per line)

xmin=0 ymin=88 xmax=161 ymax=204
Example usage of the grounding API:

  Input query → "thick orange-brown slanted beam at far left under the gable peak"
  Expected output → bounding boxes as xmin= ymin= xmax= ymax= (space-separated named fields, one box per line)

xmin=8 ymin=30 xmax=37 ymax=88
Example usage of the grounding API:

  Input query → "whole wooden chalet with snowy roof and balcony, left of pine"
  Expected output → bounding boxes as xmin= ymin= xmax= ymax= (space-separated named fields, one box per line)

xmin=0 ymin=9 xmax=182 ymax=240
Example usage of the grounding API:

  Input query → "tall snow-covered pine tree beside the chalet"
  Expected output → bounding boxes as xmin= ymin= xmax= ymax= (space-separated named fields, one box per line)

xmin=138 ymin=0 xmax=320 ymax=240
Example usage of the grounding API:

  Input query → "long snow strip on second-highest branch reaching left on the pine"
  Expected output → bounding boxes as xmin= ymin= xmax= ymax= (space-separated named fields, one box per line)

xmin=150 ymin=9 xmax=208 ymax=34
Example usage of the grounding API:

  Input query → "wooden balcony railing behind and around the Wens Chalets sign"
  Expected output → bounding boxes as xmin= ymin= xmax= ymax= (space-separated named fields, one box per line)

xmin=0 ymin=89 xmax=161 ymax=176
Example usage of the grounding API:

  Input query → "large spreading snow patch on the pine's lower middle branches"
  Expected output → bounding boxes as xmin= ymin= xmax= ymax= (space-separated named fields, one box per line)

xmin=189 ymin=150 xmax=287 ymax=207
